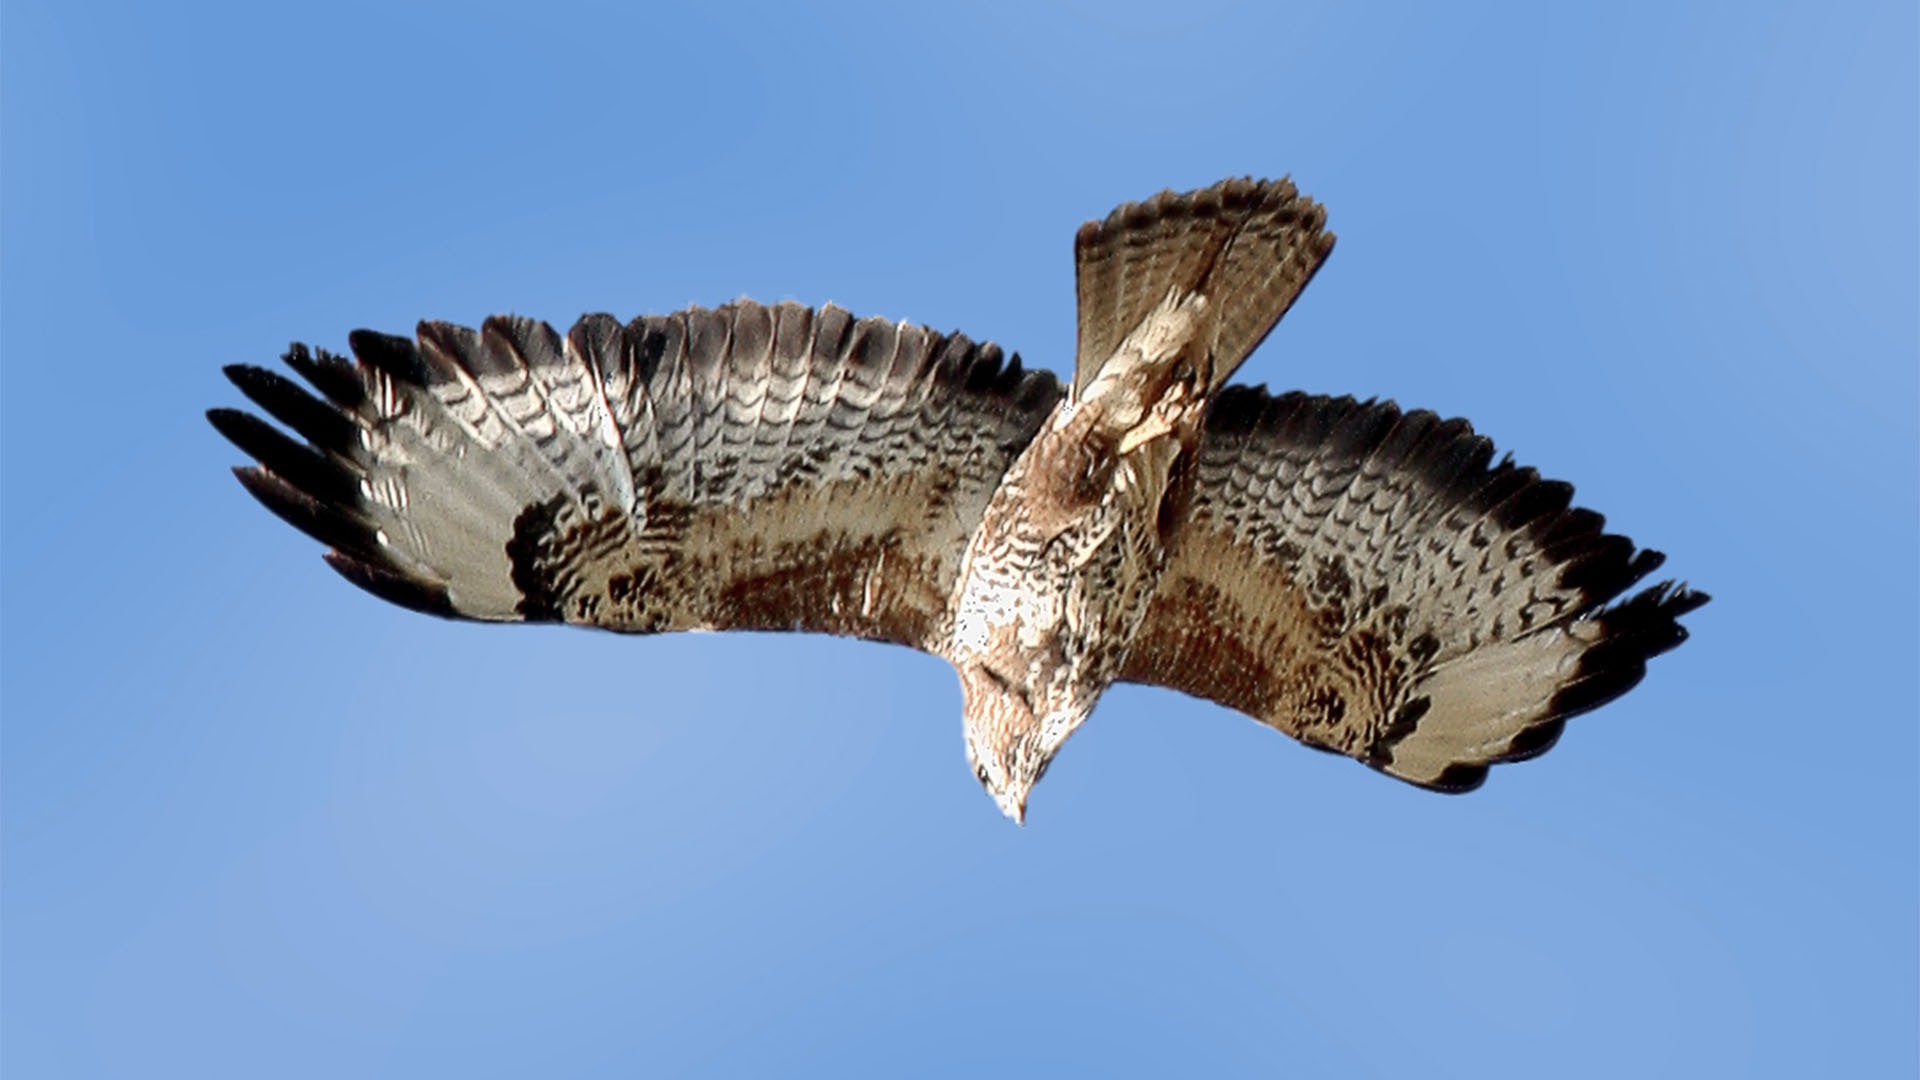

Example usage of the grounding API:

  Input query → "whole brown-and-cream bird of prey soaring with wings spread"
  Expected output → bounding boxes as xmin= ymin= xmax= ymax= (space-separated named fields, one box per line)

xmin=209 ymin=179 xmax=1707 ymax=821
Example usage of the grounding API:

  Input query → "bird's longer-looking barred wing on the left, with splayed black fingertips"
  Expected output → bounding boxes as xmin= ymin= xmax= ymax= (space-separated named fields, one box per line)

xmin=209 ymin=302 xmax=1062 ymax=650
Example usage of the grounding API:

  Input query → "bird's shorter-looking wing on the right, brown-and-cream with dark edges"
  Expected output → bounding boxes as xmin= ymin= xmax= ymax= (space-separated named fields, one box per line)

xmin=1121 ymin=386 xmax=1707 ymax=792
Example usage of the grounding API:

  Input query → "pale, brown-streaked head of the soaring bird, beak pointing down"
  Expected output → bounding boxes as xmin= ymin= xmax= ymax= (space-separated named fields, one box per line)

xmin=960 ymin=663 xmax=1085 ymax=824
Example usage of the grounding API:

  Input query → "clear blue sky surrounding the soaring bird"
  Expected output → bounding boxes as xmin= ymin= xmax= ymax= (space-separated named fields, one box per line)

xmin=0 ymin=0 xmax=1920 ymax=1080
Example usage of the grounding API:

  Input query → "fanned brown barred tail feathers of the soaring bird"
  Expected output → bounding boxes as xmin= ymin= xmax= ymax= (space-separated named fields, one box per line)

xmin=1073 ymin=179 xmax=1332 ymax=392
